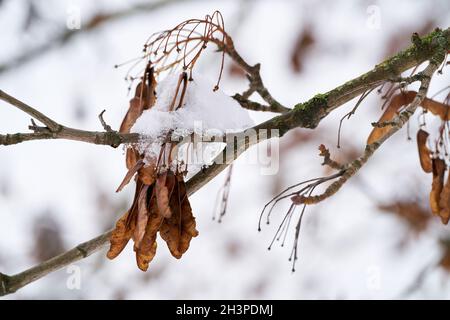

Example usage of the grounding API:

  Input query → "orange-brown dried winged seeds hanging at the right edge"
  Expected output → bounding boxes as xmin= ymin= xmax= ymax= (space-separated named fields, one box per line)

xmin=367 ymin=91 xmax=450 ymax=224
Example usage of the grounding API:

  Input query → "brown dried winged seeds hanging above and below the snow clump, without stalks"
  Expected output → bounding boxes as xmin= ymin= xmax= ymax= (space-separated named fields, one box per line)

xmin=107 ymin=63 xmax=198 ymax=271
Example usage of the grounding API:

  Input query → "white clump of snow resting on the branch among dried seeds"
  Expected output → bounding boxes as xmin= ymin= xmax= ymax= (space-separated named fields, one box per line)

xmin=131 ymin=74 xmax=254 ymax=165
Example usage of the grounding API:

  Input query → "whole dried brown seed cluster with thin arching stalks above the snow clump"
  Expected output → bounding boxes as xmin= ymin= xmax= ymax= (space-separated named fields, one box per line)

xmin=107 ymin=11 xmax=236 ymax=271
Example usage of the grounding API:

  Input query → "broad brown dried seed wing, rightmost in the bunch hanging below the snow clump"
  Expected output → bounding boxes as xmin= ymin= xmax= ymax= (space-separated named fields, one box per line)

xmin=159 ymin=175 xmax=198 ymax=259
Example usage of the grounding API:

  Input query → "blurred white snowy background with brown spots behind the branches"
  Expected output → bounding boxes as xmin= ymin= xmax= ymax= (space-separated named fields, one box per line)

xmin=0 ymin=0 xmax=450 ymax=299
